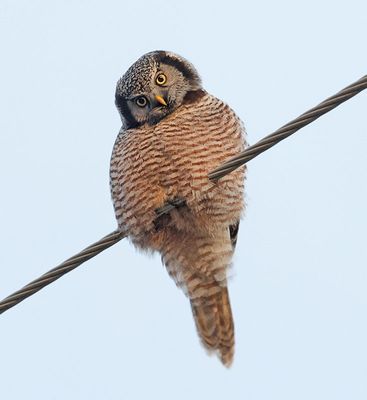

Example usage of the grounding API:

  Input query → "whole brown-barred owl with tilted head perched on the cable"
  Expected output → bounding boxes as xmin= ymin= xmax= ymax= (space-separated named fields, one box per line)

xmin=110 ymin=51 xmax=246 ymax=366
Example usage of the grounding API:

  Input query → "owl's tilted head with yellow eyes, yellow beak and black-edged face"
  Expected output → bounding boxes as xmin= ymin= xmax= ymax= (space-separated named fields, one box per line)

xmin=116 ymin=51 xmax=201 ymax=129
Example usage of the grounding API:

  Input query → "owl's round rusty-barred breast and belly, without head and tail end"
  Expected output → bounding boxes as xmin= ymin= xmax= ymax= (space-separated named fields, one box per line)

xmin=111 ymin=95 xmax=244 ymax=241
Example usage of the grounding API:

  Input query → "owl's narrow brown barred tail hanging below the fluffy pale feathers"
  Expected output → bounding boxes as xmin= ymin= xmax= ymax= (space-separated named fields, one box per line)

xmin=190 ymin=283 xmax=234 ymax=367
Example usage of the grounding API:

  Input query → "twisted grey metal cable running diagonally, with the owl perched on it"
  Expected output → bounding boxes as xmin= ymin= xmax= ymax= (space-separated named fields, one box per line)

xmin=0 ymin=75 xmax=367 ymax=314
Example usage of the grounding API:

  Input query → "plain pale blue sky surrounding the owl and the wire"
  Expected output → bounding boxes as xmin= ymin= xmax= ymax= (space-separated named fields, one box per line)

xmin=0 ymin=0 xmax=367 ymax=400
